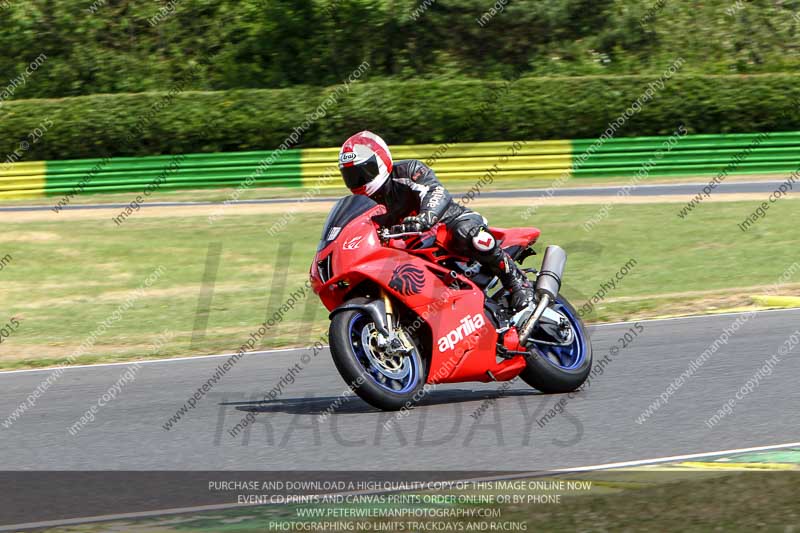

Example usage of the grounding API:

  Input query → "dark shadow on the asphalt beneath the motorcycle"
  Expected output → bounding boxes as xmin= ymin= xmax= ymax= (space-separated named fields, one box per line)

xmin=219 ymin=389 xmax=548 ymax=416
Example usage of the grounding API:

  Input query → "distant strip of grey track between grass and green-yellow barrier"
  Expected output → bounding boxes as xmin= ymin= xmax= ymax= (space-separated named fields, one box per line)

xmin=0 ymin=181 xmax=783 ymax=212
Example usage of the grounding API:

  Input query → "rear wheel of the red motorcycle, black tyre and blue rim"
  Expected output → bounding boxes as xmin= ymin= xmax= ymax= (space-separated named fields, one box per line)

xmin=520 ymin=296 xmax=592 ymax=394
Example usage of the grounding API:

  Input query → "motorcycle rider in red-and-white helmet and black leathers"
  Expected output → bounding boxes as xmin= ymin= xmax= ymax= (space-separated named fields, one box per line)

xmin=339 ymin=130 xmax=533 ymax=313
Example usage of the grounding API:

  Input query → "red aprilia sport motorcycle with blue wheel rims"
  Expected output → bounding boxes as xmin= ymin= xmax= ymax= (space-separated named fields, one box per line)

xmin=311 ymin=195 xmax=592 ymax=410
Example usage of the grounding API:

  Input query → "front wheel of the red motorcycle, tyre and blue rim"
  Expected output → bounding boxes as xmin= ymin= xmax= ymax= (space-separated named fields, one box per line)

xmin=329 ymin=302 xmax=427 ymax=411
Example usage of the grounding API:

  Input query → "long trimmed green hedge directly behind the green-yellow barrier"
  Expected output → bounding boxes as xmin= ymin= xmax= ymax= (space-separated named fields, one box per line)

xmin=0 ymin=74 xmax=800 ymax=161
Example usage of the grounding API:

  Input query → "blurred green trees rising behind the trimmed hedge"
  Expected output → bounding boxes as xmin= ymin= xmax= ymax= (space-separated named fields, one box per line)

xmin=0 ymin=0 xmax=800 ymax=99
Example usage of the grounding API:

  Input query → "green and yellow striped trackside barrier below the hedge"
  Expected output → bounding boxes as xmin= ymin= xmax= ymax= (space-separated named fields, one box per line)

xmin=0 ymin=132 xmax=800 ymax=199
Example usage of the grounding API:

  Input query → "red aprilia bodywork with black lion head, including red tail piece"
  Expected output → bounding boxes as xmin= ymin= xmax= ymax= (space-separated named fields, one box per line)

xmin=311 ymin=206 xmax=540 ymax=383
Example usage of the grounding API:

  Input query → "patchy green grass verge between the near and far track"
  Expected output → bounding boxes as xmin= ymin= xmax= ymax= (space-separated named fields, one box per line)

xmin=0 ymin=200 xmax=800 ymax=369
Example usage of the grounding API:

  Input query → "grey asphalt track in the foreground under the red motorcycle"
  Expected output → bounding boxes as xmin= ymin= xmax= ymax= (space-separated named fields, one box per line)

xmin=0 ymin=310 xmax=800 ymax=471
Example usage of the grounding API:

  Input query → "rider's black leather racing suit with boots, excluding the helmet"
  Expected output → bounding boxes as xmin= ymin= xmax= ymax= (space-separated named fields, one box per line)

xmin=372 ymin=159 xmax=532 ymax=310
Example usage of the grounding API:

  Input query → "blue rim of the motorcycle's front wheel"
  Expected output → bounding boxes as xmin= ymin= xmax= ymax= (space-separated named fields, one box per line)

xmin=347 ymin=312 xmax=422 ymax=394
